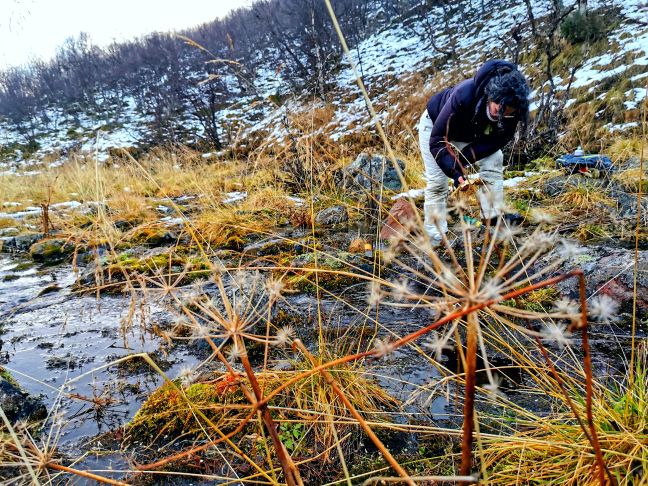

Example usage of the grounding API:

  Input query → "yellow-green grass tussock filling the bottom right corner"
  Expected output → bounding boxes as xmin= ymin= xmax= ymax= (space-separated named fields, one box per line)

xmin=484 ymin=342 xmax=648 ymax=486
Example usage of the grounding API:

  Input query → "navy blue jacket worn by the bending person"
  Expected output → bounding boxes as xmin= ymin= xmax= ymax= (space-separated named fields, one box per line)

xmin=427 ymin=59 xmax=525 ymax=185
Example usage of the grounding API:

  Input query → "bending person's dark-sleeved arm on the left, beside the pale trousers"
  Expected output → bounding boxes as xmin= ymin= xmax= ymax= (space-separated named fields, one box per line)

xmin=430 ymin=90 xmax=469 ymax=186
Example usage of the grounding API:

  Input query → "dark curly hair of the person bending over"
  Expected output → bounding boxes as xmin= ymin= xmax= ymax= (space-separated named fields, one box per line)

xmin=484 ymin=69 xmax=529 ymax=127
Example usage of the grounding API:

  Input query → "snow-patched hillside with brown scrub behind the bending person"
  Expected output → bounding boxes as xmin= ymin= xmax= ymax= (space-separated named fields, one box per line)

xmin=0 ymin=1 xmax=648 ymax=168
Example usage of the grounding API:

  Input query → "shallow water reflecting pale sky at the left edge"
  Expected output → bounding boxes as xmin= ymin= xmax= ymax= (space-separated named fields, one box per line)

xmin=0 ymin=256 xmax=196 ymax=452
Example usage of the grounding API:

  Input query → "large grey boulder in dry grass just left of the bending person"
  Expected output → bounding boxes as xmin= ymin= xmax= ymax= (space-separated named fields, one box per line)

xmin=341 ymin=152 xmax=405 ymax=192
